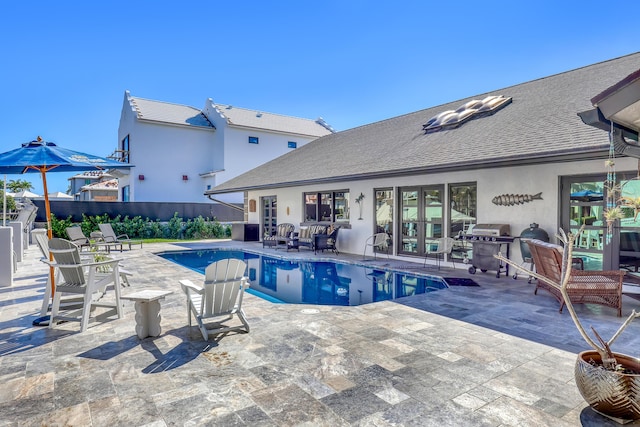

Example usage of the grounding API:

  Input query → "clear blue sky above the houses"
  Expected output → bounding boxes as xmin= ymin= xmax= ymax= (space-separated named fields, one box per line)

xmin=0 ymin=0 xmax=640 ymax=194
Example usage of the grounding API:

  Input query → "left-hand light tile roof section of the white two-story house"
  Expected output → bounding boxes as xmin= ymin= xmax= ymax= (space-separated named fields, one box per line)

xmin=130 ymin=96 xmax=213 ymax=128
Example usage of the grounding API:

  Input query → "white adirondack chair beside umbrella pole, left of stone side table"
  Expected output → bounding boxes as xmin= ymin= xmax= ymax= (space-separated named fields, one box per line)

xmin=42 ymin=238 xmax=122 ymax=332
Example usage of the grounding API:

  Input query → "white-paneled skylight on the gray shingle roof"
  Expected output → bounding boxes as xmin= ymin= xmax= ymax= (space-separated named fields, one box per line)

xmin=422 ymin=95 xmax=511 ymax=133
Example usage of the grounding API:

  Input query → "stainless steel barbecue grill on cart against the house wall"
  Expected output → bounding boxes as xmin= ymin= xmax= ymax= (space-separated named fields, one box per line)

xmin=464 ymin=224 xmax=514 ymax=277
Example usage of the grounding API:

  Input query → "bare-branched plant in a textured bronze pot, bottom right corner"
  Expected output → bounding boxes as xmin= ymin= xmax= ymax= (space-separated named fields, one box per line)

xmin=497 ymin=228 xmax=640 ymax=423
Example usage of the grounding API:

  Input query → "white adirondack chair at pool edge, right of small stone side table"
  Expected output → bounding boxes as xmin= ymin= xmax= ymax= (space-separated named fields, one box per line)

xmin=180 ymin=259 xmax=249 ymax=341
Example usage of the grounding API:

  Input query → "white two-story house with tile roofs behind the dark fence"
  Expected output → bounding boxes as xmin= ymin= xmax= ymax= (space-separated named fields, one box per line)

xmin=118 ymin=91 xmax=333 ymax=203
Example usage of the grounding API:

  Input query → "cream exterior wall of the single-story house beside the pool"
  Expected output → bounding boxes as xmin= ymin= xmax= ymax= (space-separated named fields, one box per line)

xmin=248 ymin=158 xmax=637 ymax=261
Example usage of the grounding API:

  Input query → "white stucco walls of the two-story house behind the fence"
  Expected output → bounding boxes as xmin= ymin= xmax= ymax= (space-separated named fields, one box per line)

xmin=118 ymin=95 xmax=316 ymax=203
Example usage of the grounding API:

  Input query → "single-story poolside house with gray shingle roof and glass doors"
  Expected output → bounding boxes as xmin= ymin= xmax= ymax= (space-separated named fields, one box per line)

xmin=208 ymin=53 xmax=640 ymax=268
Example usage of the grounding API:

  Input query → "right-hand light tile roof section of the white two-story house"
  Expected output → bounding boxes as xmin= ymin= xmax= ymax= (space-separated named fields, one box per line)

xmin=214 ymin=103 xmax=332 ymax=137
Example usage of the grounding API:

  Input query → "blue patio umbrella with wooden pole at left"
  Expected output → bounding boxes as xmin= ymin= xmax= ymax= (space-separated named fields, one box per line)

xmin=0 ymin=137 xmax=133 ymax=296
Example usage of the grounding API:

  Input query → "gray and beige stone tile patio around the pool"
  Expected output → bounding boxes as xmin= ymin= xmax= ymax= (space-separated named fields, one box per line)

xmin=0 ymin=242 xmax=640 ymax=427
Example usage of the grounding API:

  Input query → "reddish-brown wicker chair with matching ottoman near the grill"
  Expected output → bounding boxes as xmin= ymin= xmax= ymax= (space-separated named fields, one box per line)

xmin=527 ymin=239 xmax=625 ymax=317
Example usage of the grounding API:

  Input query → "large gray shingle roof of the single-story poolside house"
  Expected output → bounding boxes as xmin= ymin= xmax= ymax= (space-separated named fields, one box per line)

xmin=210 ymin=53 xmax=640 ymax=193
